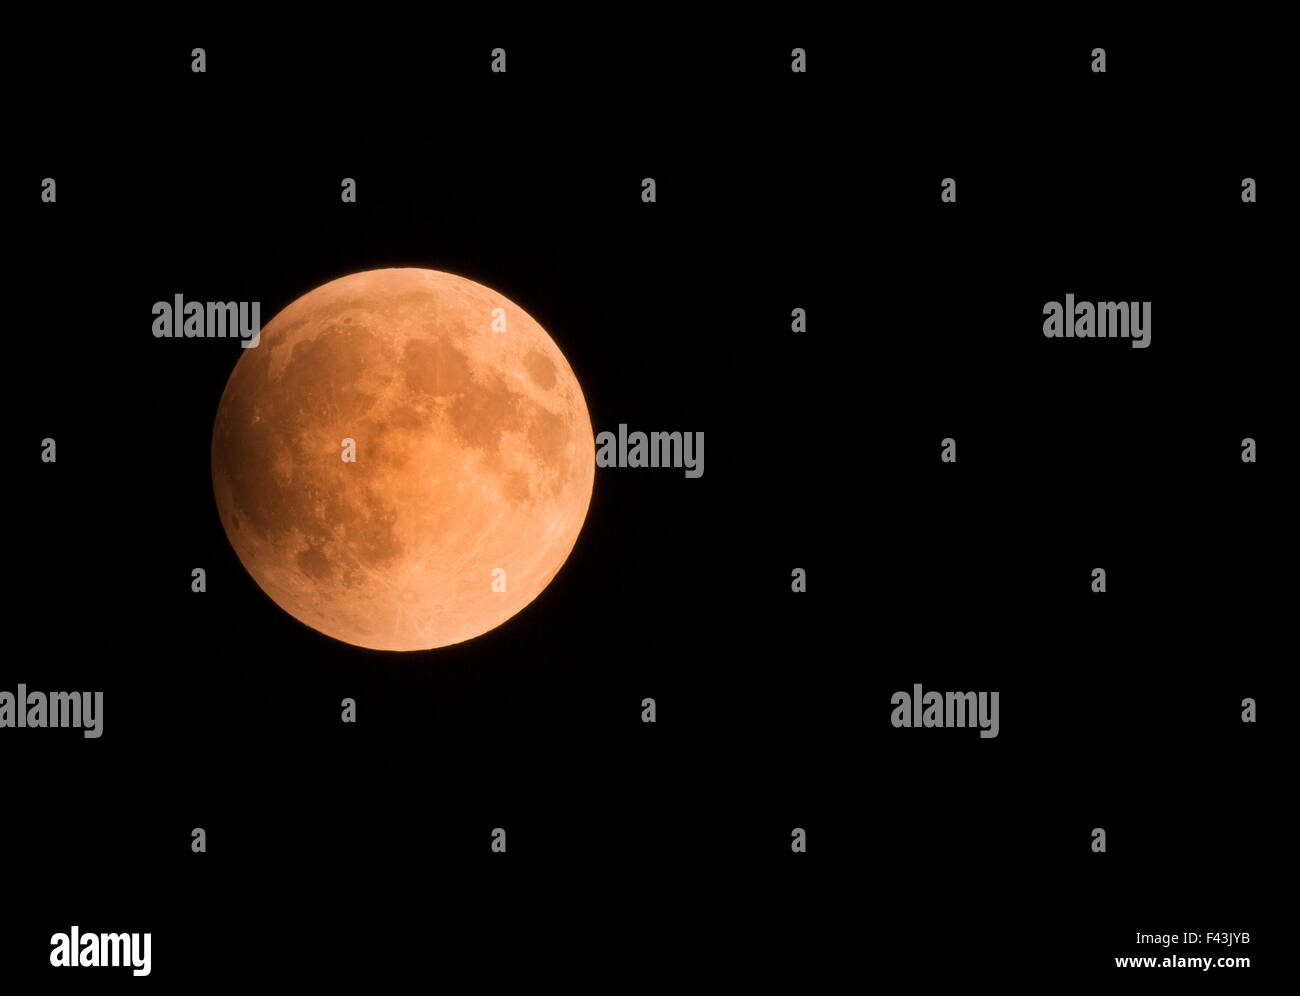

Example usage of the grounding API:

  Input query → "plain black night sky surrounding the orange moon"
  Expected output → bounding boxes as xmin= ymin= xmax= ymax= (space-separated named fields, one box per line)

xmin=0 ymin=13 xmax=1294 ymax=991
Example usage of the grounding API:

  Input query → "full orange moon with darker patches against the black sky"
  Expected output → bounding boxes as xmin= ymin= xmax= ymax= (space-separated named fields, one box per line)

xmin=212 ymin=269 xmax=595 ymax=650
